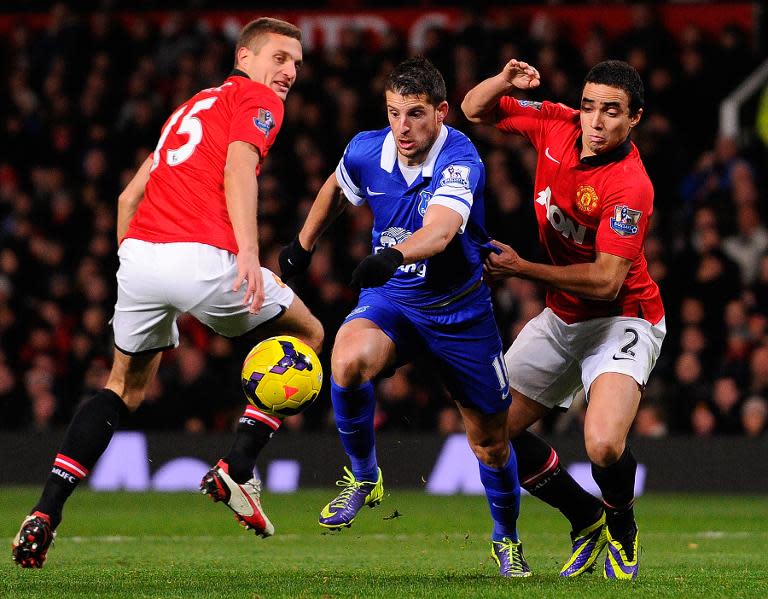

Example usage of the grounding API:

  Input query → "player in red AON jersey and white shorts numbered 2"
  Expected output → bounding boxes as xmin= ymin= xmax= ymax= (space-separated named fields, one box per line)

xmin=462 ymin=60 xmax=666 ymax=579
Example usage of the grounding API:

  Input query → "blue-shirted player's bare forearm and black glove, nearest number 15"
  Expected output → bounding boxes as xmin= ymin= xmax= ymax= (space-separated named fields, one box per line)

xmin=279 ymin=173 xmax=347 ymax=281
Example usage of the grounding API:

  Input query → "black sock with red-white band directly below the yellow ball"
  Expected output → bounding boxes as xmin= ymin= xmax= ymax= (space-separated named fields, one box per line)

xmin=222 ymin=406 xmax=282 ymax=484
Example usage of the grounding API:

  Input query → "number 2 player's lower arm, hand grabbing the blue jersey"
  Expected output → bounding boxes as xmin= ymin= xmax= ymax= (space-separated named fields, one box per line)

xmin=483 ymin=239 xmax=632 ymax=301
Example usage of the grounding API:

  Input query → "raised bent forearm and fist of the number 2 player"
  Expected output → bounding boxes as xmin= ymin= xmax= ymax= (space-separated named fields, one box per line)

xmin=461 ymin=58 xmax=541 ymax=125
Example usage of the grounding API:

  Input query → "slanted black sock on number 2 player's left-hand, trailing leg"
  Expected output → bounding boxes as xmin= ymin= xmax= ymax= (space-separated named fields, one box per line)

xmin=512 ymin=431 xmax=603 ymax=532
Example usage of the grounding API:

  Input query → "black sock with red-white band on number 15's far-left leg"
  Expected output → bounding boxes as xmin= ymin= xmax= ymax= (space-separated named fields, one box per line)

xmin=32 ymin=389 xmax=128 ymax=528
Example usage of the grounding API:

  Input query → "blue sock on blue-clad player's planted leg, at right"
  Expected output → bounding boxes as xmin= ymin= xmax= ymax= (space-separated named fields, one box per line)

xmin=478 ymin=446 xmax=520 ymax=541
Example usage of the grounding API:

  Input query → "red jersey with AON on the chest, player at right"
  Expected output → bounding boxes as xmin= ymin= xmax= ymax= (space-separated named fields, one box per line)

xmin=497 ymin=97 xmax=664 ymax=324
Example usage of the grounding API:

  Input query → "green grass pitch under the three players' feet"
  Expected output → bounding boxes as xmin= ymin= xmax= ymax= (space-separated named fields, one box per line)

xmin=0 ymin=487 xmax=768 ymax=599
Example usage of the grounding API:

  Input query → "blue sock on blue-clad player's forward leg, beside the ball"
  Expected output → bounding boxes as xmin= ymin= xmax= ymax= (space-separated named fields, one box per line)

xmin=331 ymin=377 xmax=379 ymax=482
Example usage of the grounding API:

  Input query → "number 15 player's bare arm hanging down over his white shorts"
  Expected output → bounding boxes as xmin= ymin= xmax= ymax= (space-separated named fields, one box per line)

xmin=224 ymin=141 xmax=264 ymax=314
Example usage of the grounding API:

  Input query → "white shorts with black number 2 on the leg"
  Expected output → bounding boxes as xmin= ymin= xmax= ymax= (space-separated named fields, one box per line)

xmin=504 ymin=308 xmax=667 ymax=408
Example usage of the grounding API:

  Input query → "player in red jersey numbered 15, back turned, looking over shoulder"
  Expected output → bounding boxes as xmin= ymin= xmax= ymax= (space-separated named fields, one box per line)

xmin=13 ymin=18 xmax=323 ymax=568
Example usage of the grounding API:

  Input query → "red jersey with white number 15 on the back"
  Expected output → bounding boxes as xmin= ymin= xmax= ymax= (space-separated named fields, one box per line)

xmin=126 ymin=74 xmax=283 ymax=254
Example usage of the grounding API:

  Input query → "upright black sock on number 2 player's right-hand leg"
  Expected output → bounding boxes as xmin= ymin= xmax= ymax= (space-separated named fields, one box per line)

xmin=592 ymin=447 xmax=637 ymax=539
